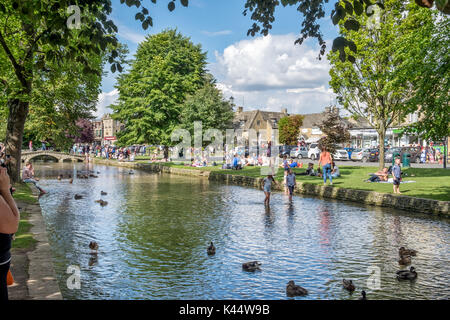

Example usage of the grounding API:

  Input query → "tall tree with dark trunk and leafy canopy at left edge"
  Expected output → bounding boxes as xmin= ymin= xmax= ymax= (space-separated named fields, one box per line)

xmin=0 ymin=0 xmax=121 ymax=181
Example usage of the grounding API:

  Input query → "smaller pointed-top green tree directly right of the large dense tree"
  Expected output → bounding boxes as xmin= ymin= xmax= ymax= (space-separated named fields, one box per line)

xmin=180 ymin=74 xmax=234 ymax=143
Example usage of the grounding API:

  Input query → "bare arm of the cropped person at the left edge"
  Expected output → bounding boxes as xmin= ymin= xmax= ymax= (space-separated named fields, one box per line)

xmin=0 ymin=168 xmax=20 ymax=234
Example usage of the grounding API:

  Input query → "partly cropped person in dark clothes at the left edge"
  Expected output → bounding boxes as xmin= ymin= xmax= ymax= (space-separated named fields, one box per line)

xmin=0 ymin=167 xmax=20 ymax=301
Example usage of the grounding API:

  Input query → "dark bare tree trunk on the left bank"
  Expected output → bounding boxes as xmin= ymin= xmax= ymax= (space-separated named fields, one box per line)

xmin=6 ymin=99 xmax=29 ymax=183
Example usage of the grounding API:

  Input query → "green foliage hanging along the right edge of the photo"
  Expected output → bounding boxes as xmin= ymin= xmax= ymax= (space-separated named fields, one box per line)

xmin=397 ymin=14 xmax=450 ymax=141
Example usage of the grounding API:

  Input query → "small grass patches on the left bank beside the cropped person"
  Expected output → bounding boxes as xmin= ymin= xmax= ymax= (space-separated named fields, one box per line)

xmin=12 ymin=184 xmax=37 ymax=250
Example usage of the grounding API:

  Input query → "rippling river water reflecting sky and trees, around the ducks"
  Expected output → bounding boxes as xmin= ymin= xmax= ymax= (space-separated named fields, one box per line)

xmin=36 ymin=164 xmax=450 ymax=299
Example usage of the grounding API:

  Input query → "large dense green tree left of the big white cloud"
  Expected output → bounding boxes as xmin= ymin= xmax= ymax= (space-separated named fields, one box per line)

xmin=112 ymin=30 xmax=206 ymax=156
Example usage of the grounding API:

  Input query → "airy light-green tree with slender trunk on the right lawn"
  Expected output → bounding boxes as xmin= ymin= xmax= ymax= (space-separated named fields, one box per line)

xmin=328 ymin=0 xmax=433 ymax=169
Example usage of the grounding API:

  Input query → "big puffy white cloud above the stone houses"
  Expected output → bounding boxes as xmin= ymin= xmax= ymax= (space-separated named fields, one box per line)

xmin=210 ymin=34 xmax=334 ymax=113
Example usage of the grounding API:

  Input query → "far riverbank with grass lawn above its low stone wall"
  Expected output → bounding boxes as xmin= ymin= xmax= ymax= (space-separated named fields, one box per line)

xmin=93 ymin=158 xmax=450 ymax=217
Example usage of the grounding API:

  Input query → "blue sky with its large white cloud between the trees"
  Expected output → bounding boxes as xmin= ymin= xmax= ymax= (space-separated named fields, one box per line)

xmin=97 ymin=0 xmax=337 ymax=116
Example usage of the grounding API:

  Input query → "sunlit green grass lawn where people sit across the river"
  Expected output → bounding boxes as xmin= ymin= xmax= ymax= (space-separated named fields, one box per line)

xmin=158 ymin=163 xmax=450 ymax=201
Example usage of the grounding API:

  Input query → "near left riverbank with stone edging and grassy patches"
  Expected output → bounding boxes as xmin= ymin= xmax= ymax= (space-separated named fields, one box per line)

xmin=8 ymin=184 xmax=62 ymax=300
